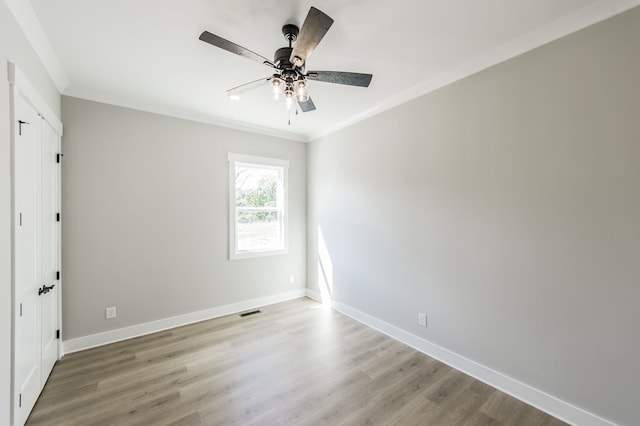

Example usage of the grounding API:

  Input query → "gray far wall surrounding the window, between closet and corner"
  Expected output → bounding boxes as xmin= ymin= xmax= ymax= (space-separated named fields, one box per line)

xmin=62 ymin=96 xmax=306 ymax=340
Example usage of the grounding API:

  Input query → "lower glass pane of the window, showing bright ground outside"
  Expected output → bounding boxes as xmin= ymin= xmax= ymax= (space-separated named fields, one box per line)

xmin=236 ymin=211 xmax=283 ymax=251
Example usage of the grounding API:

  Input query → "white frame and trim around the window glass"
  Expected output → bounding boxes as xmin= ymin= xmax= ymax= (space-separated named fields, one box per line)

xmin=228 ymin=153 xmax=289 ymax=260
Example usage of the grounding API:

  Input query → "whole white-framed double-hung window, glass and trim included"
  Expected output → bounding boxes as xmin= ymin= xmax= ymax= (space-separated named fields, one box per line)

xmin=229 ymin=153 xmax=289 ymax=259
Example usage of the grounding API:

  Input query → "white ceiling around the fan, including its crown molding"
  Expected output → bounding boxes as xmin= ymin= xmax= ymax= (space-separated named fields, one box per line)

xmin=12 ymin=0 xmax=640 ymax=140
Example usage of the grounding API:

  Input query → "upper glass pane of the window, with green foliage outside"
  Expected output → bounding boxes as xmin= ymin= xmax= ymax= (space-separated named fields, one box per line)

xmin=236 ymin=165 xmax=279 ymax=207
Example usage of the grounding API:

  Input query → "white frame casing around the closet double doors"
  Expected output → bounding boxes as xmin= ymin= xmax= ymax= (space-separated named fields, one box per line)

xmin=7 ymin=61 xmax=63 ymax=424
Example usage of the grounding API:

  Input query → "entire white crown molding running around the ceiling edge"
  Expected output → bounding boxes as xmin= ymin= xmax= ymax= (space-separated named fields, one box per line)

xmin=4 ymin=0 xmax=640 ymax=142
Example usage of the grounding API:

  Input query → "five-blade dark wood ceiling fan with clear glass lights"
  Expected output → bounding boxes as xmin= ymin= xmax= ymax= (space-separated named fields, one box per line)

xmin=200 ymin=7 xmax=373 ymax=113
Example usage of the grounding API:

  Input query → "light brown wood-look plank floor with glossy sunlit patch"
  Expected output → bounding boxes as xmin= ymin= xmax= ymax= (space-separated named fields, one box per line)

xmin=27 ymin=299 xmax=564 ymax=426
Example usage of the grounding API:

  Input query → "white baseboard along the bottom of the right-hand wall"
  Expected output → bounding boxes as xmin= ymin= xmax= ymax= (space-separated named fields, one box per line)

xmin=307 ymin=289 xmax=613 ymax=426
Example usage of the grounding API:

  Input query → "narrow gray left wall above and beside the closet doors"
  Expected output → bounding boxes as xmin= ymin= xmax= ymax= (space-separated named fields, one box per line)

xmin=0 ymin=2 xmax=60 ymax=425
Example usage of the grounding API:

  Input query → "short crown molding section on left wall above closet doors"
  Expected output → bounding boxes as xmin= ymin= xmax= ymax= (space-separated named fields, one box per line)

xmin=4 ymin=0 xmax=69 ymax=93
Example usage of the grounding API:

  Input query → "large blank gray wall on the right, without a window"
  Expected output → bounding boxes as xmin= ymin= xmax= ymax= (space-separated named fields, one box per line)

xmin=307 ymin=8 xmax=640 ymax=425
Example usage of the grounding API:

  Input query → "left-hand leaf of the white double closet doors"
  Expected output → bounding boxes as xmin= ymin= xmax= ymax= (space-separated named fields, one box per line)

xmin=14 ymin=96 xmax=42 ymax=425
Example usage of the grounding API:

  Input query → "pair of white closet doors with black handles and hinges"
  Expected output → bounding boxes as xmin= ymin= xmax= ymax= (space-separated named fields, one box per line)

xmin=14 ymin=93 xmax=60 ymax=425
